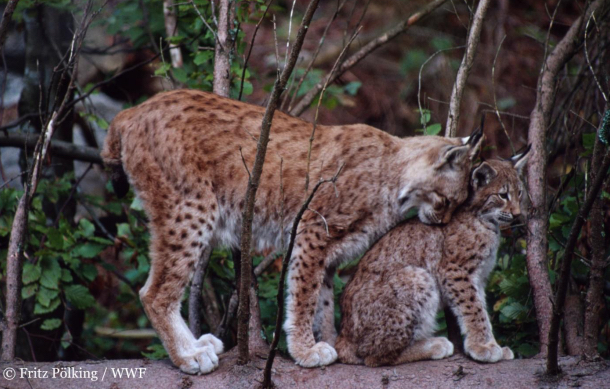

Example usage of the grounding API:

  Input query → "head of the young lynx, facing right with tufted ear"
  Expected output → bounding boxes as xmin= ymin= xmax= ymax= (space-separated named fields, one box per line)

xmin=468 ymin=147 xmax=529 ymax=226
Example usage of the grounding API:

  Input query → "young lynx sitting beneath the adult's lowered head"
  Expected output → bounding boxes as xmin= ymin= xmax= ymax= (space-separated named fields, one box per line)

xmin=336 ymin=155 xmax=526 ymax=366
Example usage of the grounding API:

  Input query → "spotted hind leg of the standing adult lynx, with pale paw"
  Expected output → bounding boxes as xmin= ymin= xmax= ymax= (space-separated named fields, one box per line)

xmin=140 ymin=186 xmax=223 ymax=374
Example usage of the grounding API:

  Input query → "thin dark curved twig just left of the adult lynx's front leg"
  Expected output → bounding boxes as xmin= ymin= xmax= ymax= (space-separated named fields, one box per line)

xmin=263 ymin=164 xmax=344 ymax=388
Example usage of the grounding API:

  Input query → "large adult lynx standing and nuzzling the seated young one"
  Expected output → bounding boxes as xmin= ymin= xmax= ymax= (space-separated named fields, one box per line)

xmin=102 ymin=90 xmax=481 ymax=373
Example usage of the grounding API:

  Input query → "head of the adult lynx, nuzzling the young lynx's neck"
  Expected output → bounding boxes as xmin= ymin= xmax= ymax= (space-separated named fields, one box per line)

xmin=398 ymin=127 xmax=483 ymax=224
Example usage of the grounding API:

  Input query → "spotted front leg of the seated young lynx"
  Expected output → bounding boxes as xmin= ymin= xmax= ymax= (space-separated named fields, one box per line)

xmin=442 ymin=271 xmax=506 ymax=362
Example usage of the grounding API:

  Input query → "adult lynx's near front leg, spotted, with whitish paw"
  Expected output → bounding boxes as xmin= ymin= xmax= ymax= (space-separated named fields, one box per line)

xmin=284 ymin=236 xmax=337 ymax=367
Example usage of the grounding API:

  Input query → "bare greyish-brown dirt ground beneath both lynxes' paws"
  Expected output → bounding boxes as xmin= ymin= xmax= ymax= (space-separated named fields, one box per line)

xmin=0 ymin=353 xmax=610 ymax=389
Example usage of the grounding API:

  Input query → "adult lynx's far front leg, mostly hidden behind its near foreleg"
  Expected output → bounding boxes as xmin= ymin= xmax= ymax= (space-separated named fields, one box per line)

xmin=313 ymin=266 xmax=337 ymax=346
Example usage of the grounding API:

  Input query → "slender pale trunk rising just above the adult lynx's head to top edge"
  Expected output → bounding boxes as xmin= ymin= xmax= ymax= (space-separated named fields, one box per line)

xmin=445 ymin=0 xmax=491 ymax=137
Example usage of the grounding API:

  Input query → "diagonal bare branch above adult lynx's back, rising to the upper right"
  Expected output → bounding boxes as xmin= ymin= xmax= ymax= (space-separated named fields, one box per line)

xmin=290 ymin=0 xmax=447 ymax=116
